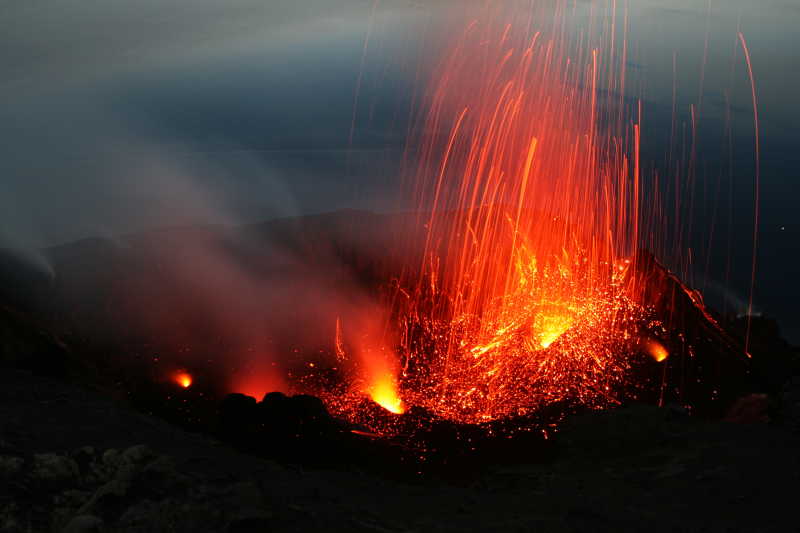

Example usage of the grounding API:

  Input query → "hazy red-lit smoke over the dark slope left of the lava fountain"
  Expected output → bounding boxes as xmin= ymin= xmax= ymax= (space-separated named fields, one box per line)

xmin=31 ymin=212 xmax=418 ymax=397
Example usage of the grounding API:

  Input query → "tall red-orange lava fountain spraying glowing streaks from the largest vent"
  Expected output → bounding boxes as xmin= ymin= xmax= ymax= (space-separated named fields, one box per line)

xmin=328 ymin=2 xmax=657 ymax=423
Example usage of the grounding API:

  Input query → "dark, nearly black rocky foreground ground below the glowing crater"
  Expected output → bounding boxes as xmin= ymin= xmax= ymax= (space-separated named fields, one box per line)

xmin=0 ymin=368 xmax=800 ymax=532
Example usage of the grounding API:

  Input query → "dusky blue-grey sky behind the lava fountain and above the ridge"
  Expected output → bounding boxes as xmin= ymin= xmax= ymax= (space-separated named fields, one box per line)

xmin=0 ymin=0 xmax=800 ymax=341
